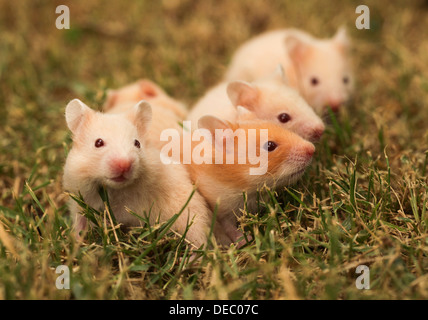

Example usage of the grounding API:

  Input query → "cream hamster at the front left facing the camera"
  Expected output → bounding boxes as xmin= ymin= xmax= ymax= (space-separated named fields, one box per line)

xmin=63 ymin=99 xmax=212 ymax=247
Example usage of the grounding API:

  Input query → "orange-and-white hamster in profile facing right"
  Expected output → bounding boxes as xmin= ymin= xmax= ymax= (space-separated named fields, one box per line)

xmin=183 ymin=116 xmax=315 ymax=245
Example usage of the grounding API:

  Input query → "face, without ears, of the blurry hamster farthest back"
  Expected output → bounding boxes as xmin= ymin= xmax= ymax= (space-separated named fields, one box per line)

xmin=300 ymin=43 xmax=353 ymax=113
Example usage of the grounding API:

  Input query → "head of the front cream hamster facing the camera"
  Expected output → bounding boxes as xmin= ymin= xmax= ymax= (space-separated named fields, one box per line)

xmin=65 ymin=99 xmax=151 ymax=189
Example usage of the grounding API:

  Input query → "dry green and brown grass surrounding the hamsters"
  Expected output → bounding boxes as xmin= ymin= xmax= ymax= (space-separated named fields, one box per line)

xmin=0 ymin=0 xmax=428 ymax=299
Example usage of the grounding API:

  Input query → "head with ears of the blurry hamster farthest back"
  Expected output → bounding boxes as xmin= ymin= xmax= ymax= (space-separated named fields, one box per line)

xmin=285 ymin=28 xmax=353 ymax=114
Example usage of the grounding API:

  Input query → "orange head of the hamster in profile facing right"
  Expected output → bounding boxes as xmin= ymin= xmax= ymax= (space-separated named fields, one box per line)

xmin=198 ymin=116 xmax=315 ymax=189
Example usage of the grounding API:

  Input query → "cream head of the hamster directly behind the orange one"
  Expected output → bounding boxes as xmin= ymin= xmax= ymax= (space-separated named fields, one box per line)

xmin=227 ymin=68 xmax=325 ymax=142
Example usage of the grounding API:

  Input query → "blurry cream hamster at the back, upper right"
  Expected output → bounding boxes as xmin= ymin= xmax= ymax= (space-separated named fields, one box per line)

xmin=225 ymin=28 xmax=354 ymax=114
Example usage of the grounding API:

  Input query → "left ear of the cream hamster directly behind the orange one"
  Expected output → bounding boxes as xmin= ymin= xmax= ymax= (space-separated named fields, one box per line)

xmin=227 ymin=81 xmax=259 ymax=111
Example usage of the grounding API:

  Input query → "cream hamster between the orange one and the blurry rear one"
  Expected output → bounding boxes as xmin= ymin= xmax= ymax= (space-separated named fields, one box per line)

xmin=188 ymin=66 xmax=325 ymax=142
